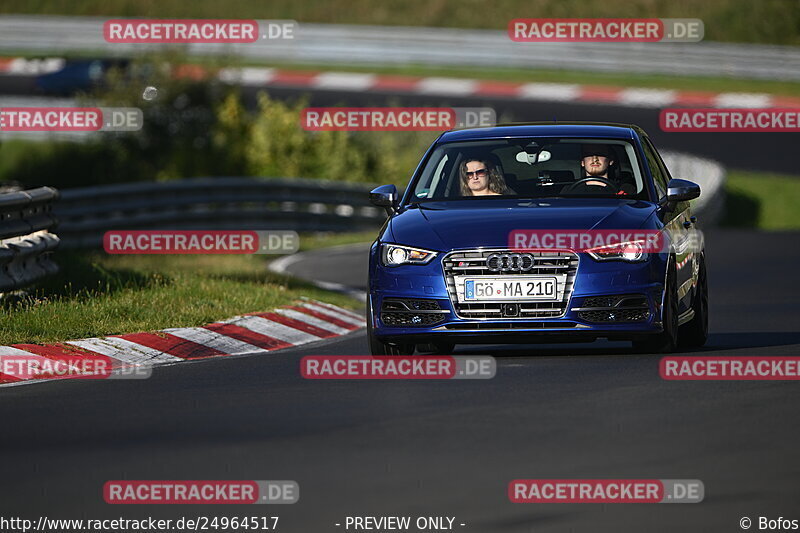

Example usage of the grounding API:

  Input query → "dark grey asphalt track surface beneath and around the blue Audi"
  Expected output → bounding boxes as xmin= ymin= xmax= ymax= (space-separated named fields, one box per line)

xmin=0 ymin=230 xmax=800 ymax=533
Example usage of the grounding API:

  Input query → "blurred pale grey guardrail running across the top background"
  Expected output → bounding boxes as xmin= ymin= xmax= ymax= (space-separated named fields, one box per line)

xmin=0 ymin=15 xmax=800 ymax=80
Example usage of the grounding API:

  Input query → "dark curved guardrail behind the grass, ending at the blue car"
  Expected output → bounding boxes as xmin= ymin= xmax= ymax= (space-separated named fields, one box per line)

xmin=56 ymin=178 xmax=385 ymax=248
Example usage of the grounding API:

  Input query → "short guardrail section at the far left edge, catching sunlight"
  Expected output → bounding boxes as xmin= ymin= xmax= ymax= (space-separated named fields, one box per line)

xmin=0 ymin=187 xmax=58 ymax=292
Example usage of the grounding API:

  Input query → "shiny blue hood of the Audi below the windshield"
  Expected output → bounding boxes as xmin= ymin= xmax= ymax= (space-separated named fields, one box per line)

xmin=390 ymin=198 xmax=656 ymax=251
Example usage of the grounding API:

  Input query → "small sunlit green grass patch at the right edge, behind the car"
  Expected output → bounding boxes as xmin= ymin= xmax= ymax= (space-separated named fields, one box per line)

xmin=722 ymin=170 xmax=800 ymax=230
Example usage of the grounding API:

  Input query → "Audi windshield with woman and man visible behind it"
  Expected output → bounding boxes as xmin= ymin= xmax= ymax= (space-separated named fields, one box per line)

xmin=410 ymin=137 xmax=648 ymax=203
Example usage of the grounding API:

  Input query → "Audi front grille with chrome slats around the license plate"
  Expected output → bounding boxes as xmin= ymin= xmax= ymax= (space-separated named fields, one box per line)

xmin=442 ymin=249 xmax=579 ymax=320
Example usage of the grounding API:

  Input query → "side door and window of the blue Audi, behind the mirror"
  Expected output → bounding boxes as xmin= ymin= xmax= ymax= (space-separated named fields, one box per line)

xmin=643 ymin=137 xmax=699 ymax=313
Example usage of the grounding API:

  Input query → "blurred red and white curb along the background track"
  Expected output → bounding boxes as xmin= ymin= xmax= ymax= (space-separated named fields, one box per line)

xmin=0 ymin=58 xmax=800 ymax=108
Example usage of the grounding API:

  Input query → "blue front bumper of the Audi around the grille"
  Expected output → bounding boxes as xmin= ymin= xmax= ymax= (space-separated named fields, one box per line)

xmin=368 ymin=244 xmax=667 ymax=344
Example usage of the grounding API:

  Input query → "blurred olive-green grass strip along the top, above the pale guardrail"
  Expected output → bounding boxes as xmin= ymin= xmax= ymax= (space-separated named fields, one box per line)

xmin=0 ymin=0 xmax=800 ymax=44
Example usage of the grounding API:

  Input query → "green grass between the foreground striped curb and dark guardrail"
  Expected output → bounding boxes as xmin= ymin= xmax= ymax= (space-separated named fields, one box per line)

xmin=0 ymin=246 xmax=360 ymax=345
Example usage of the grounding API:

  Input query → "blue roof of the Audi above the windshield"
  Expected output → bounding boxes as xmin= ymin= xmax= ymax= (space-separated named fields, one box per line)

xmin=438 ymin=122 xmax=644 ymax=143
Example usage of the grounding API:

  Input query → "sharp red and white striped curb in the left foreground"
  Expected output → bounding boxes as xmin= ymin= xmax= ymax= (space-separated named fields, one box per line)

xmin=0 ymin=299 xmax=366 ymax=387
